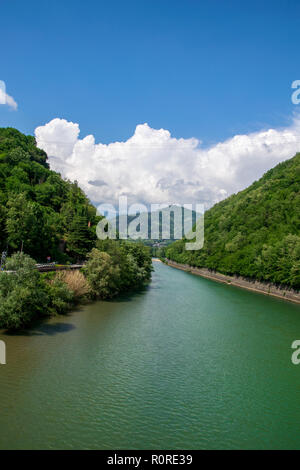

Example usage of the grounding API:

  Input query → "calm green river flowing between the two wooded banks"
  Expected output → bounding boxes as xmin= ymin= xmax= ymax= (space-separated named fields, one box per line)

xmin=0 ymin=262 xmax=300 ymax=449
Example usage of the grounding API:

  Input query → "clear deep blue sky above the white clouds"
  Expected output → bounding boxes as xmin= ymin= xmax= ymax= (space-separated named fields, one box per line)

xmin=0 ymin=0 xmax=300 ymax=145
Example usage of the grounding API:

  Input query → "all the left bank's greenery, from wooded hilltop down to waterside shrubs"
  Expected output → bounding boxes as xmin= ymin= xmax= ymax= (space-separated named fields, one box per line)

xmin=0 ymin=128 xmax=152 ymax=329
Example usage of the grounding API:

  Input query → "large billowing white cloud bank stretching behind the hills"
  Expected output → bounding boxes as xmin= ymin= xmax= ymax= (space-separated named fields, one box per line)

xmin=35 ymin=117 xmax=300 ymax=208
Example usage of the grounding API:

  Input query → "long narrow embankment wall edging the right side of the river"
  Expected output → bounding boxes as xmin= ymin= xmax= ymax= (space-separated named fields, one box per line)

xmin=165 ymin=259 xmax=300 ymax=304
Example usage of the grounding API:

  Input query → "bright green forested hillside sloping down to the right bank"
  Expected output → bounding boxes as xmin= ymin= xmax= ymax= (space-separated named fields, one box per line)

xmin=166 ymin=153 xmax=300 ymax=289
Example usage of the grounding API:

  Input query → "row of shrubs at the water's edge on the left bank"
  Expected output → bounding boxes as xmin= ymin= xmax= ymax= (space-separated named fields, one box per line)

xmin=0 ymin=240 xmax=152 ymax=330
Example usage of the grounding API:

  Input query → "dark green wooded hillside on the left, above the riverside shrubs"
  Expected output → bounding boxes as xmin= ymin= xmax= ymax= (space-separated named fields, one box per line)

xmin=0 ymin=128 xmax=99 ymax=262
